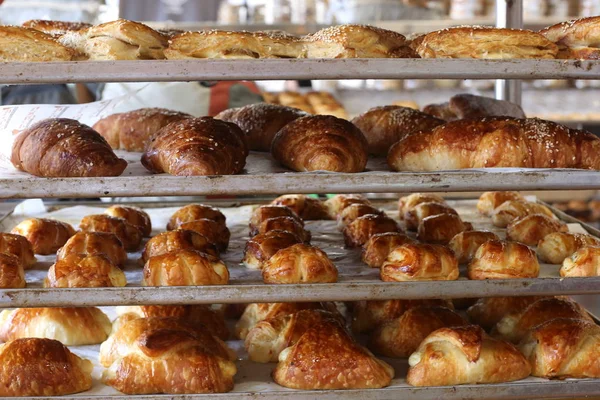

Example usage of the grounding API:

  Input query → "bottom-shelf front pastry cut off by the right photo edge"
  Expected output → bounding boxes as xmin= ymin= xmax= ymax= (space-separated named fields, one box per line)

xmin=519 ymin=318 xmax=600 ymax=379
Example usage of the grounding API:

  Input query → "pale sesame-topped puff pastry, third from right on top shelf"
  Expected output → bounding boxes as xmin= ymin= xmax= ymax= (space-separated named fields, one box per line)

xmin=305 ymin=25 xmax=416 ymax=58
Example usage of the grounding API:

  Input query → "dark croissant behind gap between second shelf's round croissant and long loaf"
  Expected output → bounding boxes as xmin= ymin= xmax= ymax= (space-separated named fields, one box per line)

xmin=352 ymin=106 xmax=444 ymax=156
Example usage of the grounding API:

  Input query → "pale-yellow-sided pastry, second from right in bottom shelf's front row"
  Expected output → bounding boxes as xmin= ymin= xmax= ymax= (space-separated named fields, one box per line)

xmin=406 ymin=325 xmax=531 ymax=386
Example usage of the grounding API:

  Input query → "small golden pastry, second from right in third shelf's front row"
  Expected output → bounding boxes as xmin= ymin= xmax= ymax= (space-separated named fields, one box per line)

xmin=467 ymin=240 xmax=540 ymax=279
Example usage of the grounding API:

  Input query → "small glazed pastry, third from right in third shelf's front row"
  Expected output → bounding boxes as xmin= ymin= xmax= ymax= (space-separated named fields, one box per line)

xmin=380 ymin=243 xmax=458 ymax=282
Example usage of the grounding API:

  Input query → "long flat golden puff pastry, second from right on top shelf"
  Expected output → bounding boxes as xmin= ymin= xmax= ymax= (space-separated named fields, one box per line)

xmin=417 ymin=26 xmax=558 ymax=60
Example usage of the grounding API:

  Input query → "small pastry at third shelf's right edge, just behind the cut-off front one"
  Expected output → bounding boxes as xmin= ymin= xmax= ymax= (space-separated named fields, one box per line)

xmin=537 ymin=232 xmax=600 ymax=264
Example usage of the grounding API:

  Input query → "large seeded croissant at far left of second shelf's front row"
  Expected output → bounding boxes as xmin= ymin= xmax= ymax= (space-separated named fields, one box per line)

xmin=10 ymin=118 xmax=127 ymax=178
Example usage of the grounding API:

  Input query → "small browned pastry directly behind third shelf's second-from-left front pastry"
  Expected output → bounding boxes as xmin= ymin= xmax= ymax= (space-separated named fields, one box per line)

xmin=56 ymin=232 xmax=127 ymax=267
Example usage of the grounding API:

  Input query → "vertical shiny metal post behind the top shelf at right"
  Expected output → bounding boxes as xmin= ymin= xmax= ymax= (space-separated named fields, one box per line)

xmin=496 ymin=0 xmax=523 ymax=104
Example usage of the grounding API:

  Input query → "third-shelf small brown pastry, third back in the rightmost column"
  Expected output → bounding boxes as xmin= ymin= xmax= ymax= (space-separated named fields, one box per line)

xmin=506 ymin=214 xmax=569 ymax=246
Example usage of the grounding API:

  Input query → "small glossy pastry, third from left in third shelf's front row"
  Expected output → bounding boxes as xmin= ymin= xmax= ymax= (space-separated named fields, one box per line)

xmin=142 ymin=249 xmax=229 ymax=286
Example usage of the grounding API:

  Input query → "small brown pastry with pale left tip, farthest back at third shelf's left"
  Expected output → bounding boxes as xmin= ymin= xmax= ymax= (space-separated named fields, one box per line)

xmin=11 ymin=218 xmax=75 ymax=255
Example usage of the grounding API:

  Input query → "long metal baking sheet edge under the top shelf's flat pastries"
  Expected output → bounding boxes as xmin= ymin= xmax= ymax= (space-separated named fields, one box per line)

xmin=0 ymin=58 xmax=600 ymax=84
